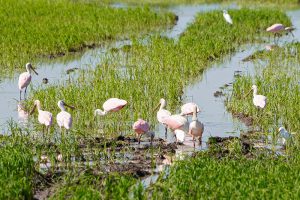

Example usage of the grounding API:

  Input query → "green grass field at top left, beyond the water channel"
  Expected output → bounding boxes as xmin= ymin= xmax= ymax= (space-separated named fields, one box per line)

xmin=0 ymin=0 xmax=174 ymax=75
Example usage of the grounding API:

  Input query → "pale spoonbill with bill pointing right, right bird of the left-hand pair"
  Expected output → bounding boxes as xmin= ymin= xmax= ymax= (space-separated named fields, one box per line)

xmin=56 ymin=100 xmax=74 ymax=131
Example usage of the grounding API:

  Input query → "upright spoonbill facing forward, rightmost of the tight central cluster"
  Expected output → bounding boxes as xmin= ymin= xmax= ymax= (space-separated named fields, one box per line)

xmin=189 ymin=106 xmax=204 ymax=147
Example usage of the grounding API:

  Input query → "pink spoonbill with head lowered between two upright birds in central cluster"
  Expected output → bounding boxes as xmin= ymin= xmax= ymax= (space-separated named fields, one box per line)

xmin=162 ymin=115 xmax=188 ymax=142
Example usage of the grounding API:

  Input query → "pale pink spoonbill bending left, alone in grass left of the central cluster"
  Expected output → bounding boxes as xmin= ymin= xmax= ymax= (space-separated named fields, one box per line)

xmin=95 ymin=98 xmax=127 ymax=116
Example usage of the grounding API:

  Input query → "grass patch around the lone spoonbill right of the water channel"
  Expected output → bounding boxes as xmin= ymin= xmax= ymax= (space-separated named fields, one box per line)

xmin=227 ymin=43 xmax=300 ymax=132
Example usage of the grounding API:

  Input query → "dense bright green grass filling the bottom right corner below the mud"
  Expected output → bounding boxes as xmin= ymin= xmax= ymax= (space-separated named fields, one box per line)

xmin=149 ymin=152 xmax=300 ymax=199
